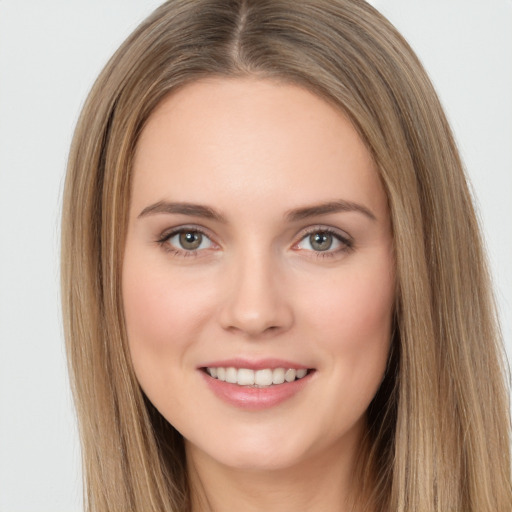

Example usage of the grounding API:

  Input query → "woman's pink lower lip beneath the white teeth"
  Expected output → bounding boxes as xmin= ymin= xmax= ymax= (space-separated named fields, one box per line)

xmin=201 ymin=370 xmax=314 ymax=411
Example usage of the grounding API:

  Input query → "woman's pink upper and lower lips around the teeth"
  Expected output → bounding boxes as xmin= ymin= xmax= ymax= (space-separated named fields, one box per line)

xmin=200 ymin=359 xmax=315 ymax=411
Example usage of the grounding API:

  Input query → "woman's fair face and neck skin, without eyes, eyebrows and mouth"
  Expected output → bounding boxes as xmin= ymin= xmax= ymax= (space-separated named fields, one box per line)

xmin=122 ymin=78 xmax=394 ymax=512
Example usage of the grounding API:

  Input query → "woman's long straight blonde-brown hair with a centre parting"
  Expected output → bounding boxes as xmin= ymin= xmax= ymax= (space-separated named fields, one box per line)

xmin=62 ymin=0 xmax=512 ymax=512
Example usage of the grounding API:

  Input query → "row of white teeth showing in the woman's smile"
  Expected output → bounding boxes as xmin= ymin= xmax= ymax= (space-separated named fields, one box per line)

xmin=206 ymin=367 xmax=308 ymax=387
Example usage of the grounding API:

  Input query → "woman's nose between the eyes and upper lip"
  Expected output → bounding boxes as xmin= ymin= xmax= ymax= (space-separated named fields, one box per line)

xmin=220 ymin=253 xmax=294 ymax=338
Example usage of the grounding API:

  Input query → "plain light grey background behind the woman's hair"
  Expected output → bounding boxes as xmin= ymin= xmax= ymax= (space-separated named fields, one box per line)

xmin=0 ymin=0 xmax=512 ymax=512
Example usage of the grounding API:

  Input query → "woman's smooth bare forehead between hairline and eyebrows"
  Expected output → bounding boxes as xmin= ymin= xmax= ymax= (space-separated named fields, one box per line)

xmin=133 ymin=78 xmax=386 ymax=220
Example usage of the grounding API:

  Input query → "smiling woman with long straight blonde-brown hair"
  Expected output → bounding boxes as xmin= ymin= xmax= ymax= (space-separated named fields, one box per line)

xmin=63 ymin=0 xmax=512 ymax=512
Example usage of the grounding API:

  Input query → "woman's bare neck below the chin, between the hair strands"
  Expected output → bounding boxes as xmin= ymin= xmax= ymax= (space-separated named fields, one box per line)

xmin=186 ymin=426 xmax=366 ymax=512
